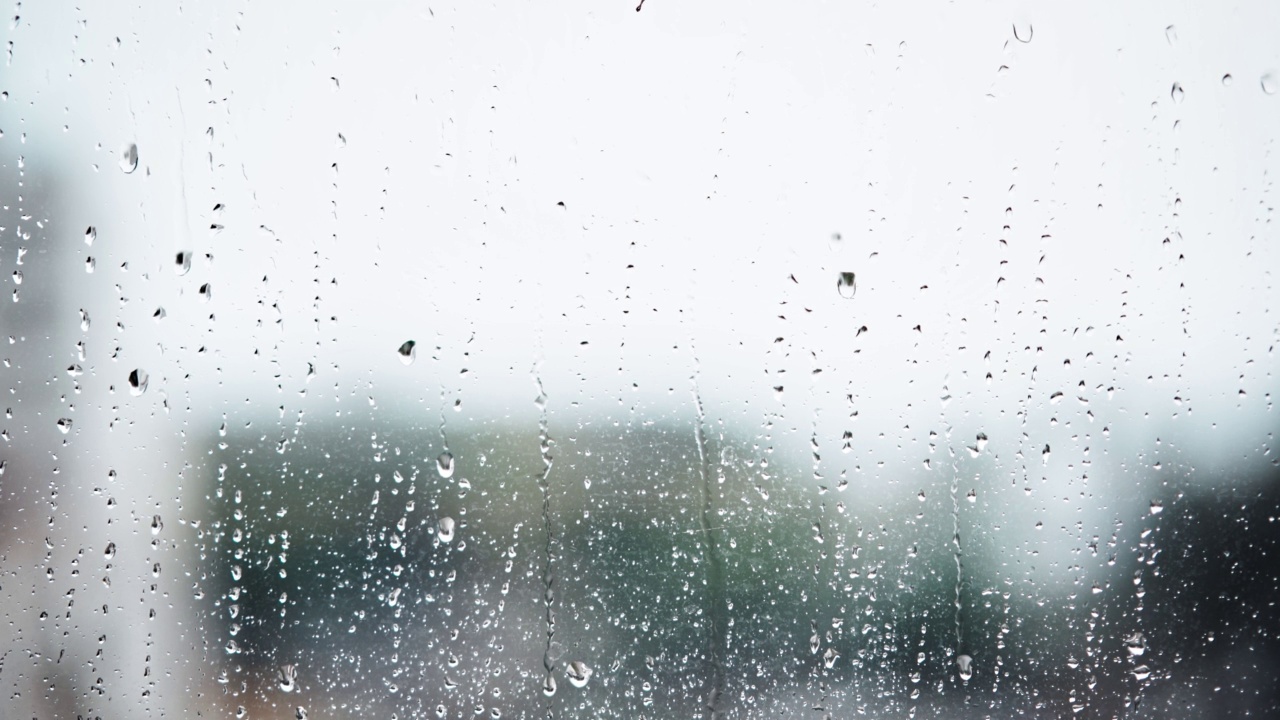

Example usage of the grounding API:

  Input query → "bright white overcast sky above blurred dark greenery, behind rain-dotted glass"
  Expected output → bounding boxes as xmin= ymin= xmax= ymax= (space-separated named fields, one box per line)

xmin=0 ymin=0 xmax=1280 ymax=489
